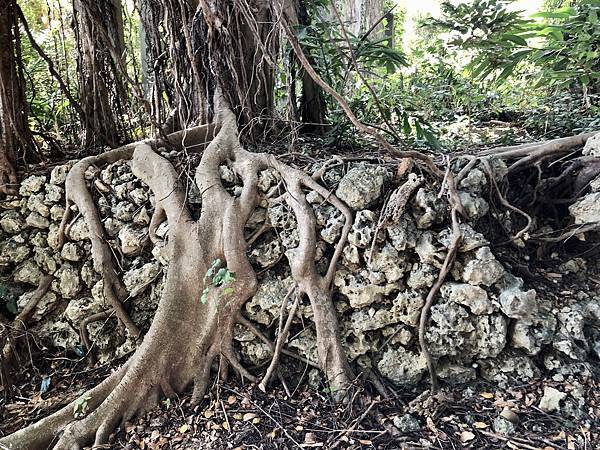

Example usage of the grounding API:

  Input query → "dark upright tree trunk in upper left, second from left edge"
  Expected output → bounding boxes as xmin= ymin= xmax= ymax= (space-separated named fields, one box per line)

xmin=73 ymin=0 xmax=127 ymax=147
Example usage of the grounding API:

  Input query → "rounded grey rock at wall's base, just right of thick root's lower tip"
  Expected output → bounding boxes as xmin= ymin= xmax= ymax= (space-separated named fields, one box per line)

xmin=377 ymin=347 xmax=427 ymax=386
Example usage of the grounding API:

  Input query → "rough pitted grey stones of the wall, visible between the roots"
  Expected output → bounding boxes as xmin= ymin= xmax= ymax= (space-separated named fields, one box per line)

xmin=0 ymin=153 xmax=600 ymax=388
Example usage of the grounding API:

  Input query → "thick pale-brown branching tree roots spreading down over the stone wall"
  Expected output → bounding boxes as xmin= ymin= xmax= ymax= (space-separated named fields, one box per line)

xmin=0 ymin=110 xmax=354 ymax=450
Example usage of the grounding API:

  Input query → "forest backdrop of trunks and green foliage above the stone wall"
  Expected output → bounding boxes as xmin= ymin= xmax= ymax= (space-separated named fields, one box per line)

xmin=0 ymin=0 xmax=600 ymax=183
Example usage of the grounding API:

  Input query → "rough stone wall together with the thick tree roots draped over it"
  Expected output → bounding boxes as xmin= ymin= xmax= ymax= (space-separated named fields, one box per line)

xmin=0 ymin=117 xmax=600 ymax=449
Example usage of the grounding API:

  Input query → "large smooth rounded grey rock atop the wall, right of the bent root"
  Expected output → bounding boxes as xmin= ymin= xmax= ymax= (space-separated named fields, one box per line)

xmin=335 ymin=164 xmax=389 ymax=211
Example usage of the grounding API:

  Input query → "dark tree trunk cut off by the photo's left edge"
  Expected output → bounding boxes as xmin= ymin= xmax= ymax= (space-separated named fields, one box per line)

xmin=0 ymin=0 xmax=35 ymax=194
